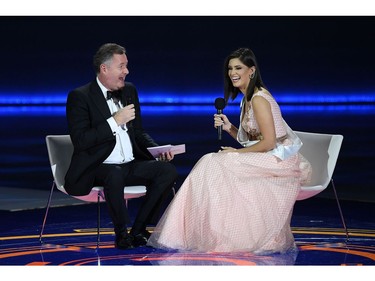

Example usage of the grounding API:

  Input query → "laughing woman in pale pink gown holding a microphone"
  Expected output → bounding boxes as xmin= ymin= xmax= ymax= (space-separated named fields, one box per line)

xmin=148 ymin=48 xmax=311 ymax=254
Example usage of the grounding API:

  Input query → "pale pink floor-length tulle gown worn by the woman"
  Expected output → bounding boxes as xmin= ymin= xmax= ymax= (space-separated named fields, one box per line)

xmin=148 ymin=92 xmax=311 ymax=254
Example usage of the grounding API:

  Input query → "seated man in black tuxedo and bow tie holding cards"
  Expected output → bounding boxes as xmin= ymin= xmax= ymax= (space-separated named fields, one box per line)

xmin=64 ymin=43 xmax=177 ymax=249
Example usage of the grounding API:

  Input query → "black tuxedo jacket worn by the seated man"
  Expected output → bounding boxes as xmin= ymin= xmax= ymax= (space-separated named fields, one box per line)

xmin=64 ymin=80 xmax=157 ymax=196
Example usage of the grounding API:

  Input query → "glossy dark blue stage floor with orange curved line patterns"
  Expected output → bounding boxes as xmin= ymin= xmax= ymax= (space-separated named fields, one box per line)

xmin=0 ymin=192 xmax=375 ymax=266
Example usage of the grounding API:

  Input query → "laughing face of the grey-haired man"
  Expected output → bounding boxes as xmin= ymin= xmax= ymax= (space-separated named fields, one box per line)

xmin=99 ymin=54 xmax=129 ymax=91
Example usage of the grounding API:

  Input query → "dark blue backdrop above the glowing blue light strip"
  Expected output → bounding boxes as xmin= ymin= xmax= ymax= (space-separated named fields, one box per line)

xmin=0 ymin=16 xmax=375 ymax=93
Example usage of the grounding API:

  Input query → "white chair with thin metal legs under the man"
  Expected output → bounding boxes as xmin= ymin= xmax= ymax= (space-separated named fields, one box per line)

xmin=39 ymin=135 xmax=146 ymax=248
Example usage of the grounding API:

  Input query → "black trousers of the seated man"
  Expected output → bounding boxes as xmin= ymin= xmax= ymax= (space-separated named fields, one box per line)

xmin=95 ymin=160 xmax=178 ymax=234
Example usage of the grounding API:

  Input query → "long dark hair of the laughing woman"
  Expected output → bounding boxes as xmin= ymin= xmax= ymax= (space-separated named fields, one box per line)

xmin=224 ymin=48 xmax=266 ymax=103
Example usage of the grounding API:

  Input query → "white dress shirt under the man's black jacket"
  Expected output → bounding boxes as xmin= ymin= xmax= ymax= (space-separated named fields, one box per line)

xmin=96 ymin=78 xmax=134 ymax=164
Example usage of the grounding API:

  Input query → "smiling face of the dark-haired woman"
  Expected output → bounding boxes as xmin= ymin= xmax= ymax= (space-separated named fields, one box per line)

xmin=228 ymin=58 xmax=255 ymax=94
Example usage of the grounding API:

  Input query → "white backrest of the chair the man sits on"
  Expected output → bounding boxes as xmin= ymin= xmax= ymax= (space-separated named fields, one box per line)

xmin=46 ymin=135 xmax=73 ymax=192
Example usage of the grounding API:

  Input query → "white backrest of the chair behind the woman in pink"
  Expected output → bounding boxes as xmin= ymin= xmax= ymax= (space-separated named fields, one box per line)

xmin=295 ymin=131 xmax=344 ymax=200
